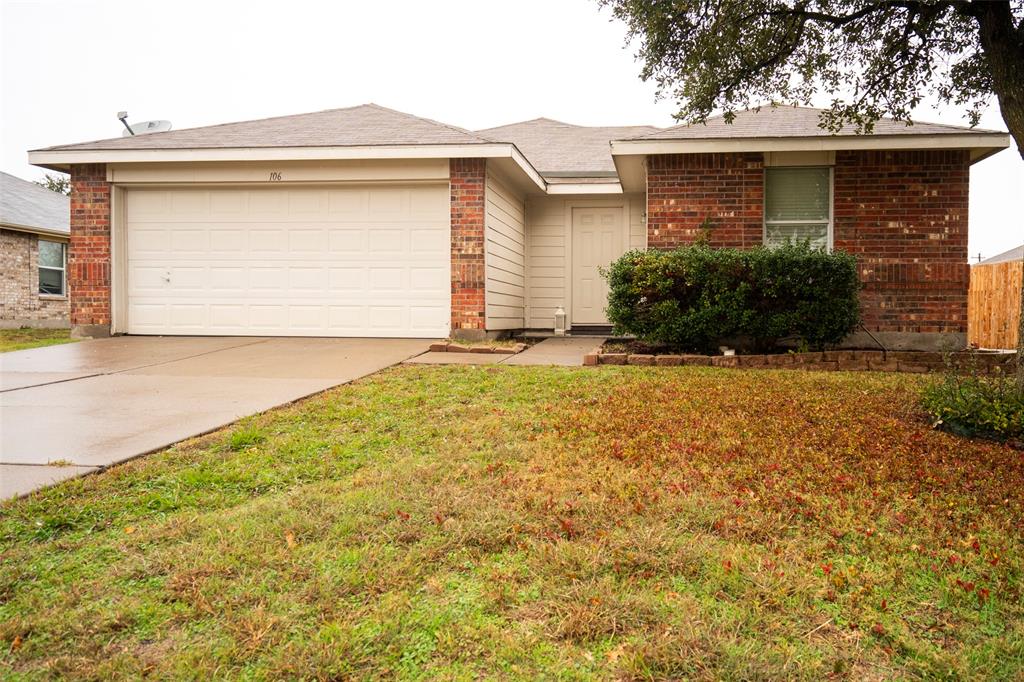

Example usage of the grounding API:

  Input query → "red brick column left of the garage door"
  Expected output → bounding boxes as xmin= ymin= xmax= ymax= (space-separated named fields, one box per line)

xmin=68 ymin=164 xmax=111 ymax=337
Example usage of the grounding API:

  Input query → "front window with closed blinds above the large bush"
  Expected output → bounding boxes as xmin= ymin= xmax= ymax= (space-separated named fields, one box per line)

xmin=765 ymin=167 xmax=831 ymax=250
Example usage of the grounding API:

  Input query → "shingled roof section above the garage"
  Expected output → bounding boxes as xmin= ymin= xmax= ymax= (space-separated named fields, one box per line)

xmin=38 ymin=103 xmax=490 ymax=152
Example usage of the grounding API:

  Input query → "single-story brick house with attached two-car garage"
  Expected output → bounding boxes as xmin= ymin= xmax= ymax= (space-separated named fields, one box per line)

xmin=29 ymin=104 xmax=1009 ymax=348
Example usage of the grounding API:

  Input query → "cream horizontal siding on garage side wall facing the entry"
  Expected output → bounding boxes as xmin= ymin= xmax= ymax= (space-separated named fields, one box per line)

xmin=484 ymin=165 xmax=526 ymax=330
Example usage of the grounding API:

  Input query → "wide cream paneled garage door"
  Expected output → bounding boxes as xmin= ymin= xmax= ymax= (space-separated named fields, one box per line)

xmin=124 ymin=185 xmax=451 ymax=337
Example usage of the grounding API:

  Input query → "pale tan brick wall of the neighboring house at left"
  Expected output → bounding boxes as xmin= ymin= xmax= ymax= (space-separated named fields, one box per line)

xmin=0 ymin=229 xmax=69 ymax=328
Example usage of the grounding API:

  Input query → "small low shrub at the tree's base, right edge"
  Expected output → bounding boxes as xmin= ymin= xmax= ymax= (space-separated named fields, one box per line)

xmin=922 ymin=360 xmax=1024 ymax=440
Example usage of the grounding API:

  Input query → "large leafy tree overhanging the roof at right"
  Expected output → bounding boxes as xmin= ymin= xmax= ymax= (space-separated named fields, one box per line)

xmin=599 ymin=0 xmax=1024 ymax=382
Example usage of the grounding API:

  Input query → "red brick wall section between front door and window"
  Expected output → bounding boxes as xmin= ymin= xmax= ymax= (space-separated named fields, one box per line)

xmin=647 ymin=154 xmax=764 ymax=249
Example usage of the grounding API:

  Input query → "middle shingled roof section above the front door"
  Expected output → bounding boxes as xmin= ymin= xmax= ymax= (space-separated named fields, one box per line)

xmin=476 ymin=119 xmax=658 ymax=177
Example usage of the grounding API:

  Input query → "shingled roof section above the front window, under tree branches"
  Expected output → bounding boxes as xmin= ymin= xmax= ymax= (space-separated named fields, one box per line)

xmin=634 ymin=105 xmax=1001 ymax=140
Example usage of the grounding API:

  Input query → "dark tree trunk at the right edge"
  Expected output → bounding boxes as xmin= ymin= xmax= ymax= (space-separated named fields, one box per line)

xmin=972 ymin=0 xmax=1024 ymax=390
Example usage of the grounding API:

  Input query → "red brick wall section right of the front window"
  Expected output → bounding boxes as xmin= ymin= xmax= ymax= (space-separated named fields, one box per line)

xmin=833 ymin=150 xmax=971 ymax=332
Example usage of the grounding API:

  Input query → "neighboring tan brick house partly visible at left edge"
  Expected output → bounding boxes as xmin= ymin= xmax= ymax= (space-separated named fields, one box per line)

xmin=0 ymin=173 xmax=71 ymax=329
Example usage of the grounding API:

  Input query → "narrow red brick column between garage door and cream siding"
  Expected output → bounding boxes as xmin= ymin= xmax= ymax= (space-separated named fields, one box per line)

xmin=450 ymin=159 xmax=486 ymax=336
